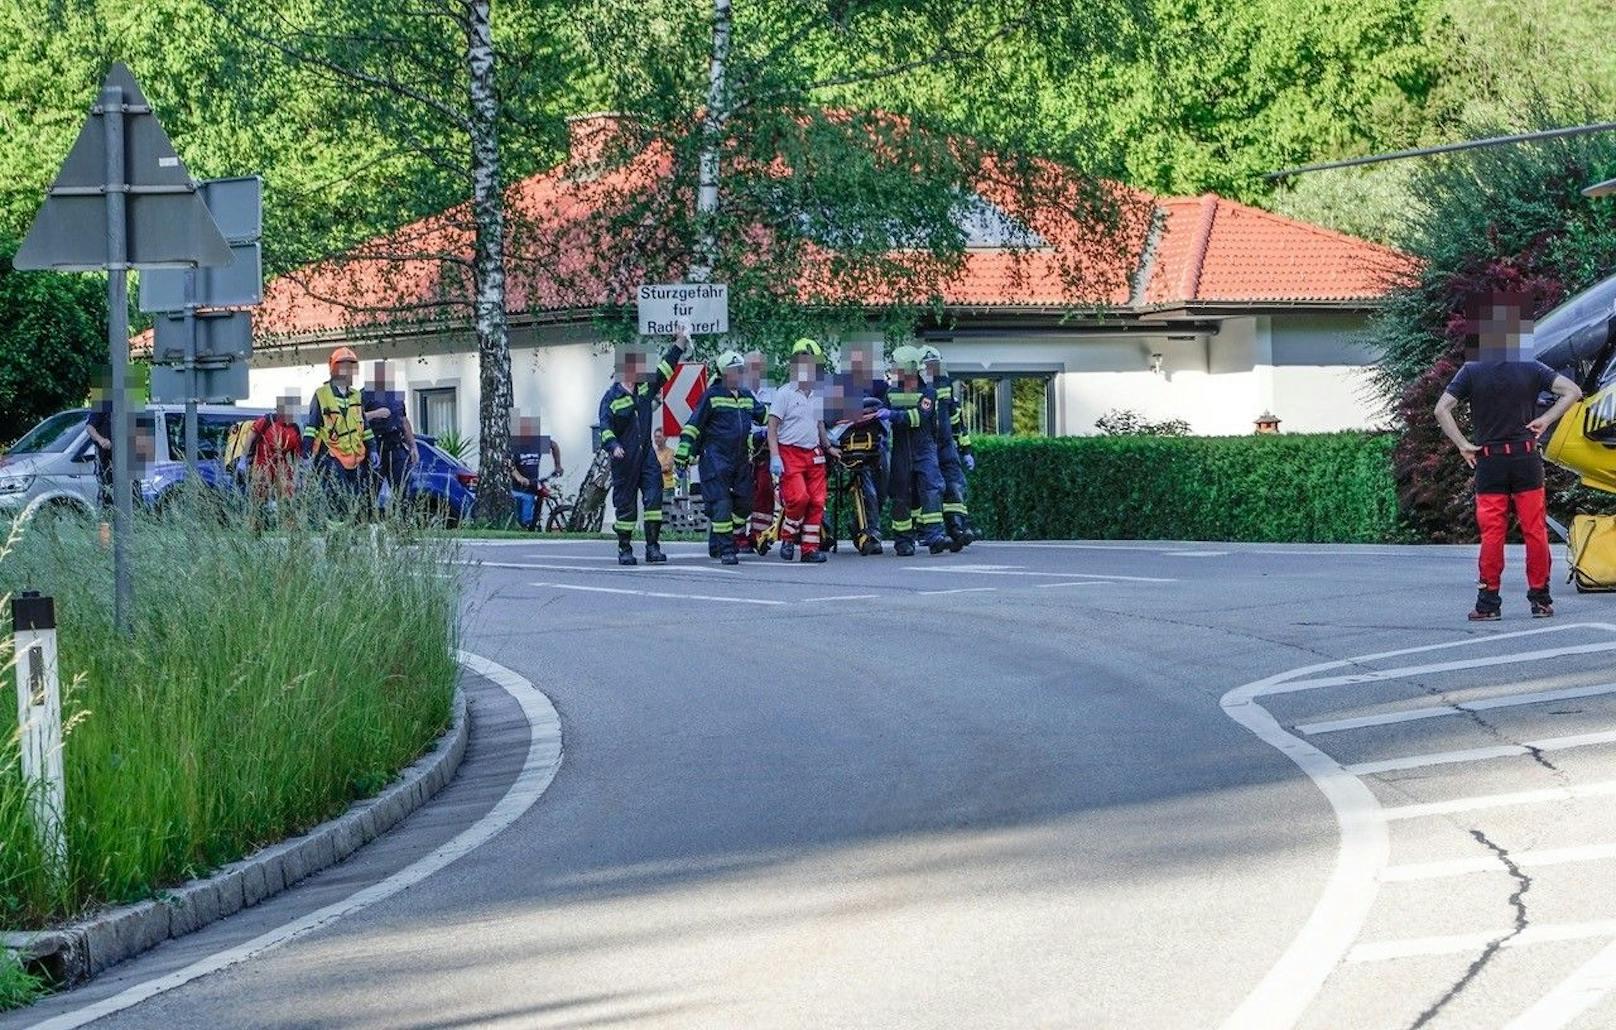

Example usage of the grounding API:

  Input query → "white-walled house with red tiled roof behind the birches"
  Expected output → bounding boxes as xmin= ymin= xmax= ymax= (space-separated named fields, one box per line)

xmin=239 ymin=116 xmax=1411 ymax=469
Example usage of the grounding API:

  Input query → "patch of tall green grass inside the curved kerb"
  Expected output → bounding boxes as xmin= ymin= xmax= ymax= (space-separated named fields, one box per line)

xmin=0 ymin=506 xmax=457 ymax=927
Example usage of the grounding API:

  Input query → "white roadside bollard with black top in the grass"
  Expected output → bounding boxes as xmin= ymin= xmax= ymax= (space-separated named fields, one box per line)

xmin=11 ymin=590 xmax=68 ymax=873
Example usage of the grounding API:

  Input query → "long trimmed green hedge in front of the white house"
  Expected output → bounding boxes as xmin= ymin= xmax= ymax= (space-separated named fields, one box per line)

xmin=970 ymin=432 xmax=1399 ymax=543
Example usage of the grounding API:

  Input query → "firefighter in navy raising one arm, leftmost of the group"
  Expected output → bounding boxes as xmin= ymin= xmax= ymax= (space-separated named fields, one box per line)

xmin=600 ymin=328 xmax=690 ymax=564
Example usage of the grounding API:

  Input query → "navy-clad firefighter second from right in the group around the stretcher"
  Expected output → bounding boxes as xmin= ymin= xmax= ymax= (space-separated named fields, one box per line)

xmin=881 ymin=346 xmax=949 ymax=558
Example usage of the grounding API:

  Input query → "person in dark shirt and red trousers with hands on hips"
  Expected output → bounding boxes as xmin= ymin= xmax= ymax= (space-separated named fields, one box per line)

xmin=1437 ymin=294 xmax=1582 ymax=623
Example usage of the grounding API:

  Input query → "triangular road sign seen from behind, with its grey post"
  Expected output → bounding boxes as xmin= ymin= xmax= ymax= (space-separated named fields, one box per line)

xmin=13 ymin=65 xmax=231 ymax=632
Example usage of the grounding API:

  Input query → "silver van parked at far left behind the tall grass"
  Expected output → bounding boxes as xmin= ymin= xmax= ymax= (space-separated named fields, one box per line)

xmin=0 ymin=404 xmax=265 ymax=519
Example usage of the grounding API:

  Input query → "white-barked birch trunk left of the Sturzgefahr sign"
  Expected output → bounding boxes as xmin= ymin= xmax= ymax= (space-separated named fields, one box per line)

xmin=465 ymin=0 xmax=514 ymax=522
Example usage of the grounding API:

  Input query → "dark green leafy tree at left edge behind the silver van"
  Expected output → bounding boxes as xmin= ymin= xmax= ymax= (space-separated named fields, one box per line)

xmin=0 ymin=238 xmax=107 ymax=443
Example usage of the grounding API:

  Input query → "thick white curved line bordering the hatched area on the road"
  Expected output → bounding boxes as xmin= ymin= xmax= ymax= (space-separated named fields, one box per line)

xmin=1220 ymin=624 xmax=1616 ymax=1030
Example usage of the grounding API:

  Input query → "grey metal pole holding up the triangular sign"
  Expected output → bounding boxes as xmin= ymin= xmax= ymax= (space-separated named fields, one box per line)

xmin=102 ymin=86 xmax=134 ymax=634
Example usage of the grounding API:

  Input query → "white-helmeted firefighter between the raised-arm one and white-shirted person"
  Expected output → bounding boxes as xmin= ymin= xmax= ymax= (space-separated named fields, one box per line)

xmin=674 ymin=351 xmax=768 ymax=564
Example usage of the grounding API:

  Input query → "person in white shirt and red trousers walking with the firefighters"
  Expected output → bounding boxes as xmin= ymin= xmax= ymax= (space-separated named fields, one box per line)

xmin=769 ymin=340 xmax=839 ymax=564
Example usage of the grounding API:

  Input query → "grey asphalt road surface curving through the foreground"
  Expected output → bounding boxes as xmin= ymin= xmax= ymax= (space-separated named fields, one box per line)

xmin=6 ymin=542 xmax=1616 ymax=1030
